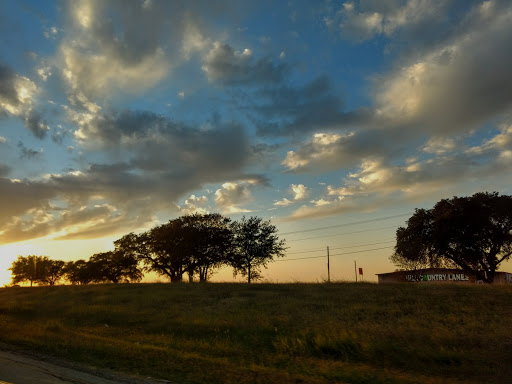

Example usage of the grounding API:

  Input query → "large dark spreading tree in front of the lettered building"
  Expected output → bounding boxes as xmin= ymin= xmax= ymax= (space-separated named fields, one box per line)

xmin=390 ymin=192 xmax=512 ymax=283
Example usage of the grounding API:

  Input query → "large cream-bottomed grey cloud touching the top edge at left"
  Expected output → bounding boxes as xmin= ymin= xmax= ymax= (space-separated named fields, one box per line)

xmin=57 ymin=0 xmax=213 ymax=105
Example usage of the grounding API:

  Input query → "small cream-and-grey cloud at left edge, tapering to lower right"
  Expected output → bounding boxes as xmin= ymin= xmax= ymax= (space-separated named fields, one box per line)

xmin=0 ymin=62 xmax=50 ymax=139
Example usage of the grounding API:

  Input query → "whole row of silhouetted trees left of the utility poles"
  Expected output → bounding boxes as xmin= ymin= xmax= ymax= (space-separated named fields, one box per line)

xmin=9 ymin=213 xmax=286 ymax=286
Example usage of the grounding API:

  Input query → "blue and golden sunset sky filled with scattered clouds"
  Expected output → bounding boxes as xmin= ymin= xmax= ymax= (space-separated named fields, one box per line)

xmin=0 ymin=0 xmax=512 ymax=284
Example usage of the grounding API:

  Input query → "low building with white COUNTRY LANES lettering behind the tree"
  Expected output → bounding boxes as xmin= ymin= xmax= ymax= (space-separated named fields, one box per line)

xmin=377 ymin=268 xmax=512 ymax=284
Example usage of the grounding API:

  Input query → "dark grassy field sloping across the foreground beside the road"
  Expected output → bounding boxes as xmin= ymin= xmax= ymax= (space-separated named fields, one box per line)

xmin=0 ymin=283 xmax=512 ymax=384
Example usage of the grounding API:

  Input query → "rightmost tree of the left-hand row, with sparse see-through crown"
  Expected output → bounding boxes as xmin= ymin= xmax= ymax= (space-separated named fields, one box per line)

xmin=230 ymin=216 xmax=286 ymax=284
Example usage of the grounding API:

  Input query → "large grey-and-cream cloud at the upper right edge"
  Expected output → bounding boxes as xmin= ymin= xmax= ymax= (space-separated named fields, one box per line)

xmin=375 ymin=2 xmax=512 ymax=136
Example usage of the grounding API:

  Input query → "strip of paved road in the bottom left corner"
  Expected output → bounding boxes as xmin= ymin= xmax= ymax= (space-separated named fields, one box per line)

xmin=0 ymin=350 xmax=169 ymax=384
